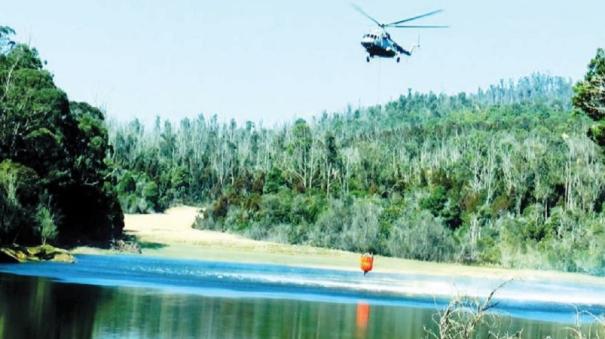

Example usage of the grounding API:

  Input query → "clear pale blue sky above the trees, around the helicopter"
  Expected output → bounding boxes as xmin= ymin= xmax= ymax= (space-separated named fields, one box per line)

xmin=0 ymin=0 xmax=605 ymax=125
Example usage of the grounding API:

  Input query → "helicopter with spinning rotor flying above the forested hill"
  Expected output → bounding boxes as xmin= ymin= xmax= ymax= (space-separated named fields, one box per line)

xmin=352 ymin=5 xmax=449 ymax=62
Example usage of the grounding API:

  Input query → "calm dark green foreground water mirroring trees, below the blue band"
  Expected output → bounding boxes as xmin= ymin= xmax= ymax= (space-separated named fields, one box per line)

xmin=0 ymin=274 xmax=600 ymax=339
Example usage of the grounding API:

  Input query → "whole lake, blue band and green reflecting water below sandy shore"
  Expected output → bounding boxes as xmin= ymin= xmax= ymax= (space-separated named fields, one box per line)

xmin=0 ymin=255 xmax=605 ymax=338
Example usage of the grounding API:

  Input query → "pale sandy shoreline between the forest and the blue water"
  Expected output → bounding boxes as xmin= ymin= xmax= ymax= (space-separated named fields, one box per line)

xmin=73 ymin=206 xmax=605 ymax=286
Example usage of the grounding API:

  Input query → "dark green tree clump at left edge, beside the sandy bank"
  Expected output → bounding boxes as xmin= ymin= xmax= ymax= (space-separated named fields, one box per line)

xmin=0 ymin=27 xmax=123 ymax=244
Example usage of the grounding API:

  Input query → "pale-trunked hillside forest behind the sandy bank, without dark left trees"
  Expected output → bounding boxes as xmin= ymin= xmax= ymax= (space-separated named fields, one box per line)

xmin=110 ymin=70 xmax=605 ymax=273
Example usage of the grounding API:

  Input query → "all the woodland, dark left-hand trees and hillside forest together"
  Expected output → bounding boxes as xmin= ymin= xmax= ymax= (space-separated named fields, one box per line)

xmin=0 ymin=26 xmax=605 ymax=275
